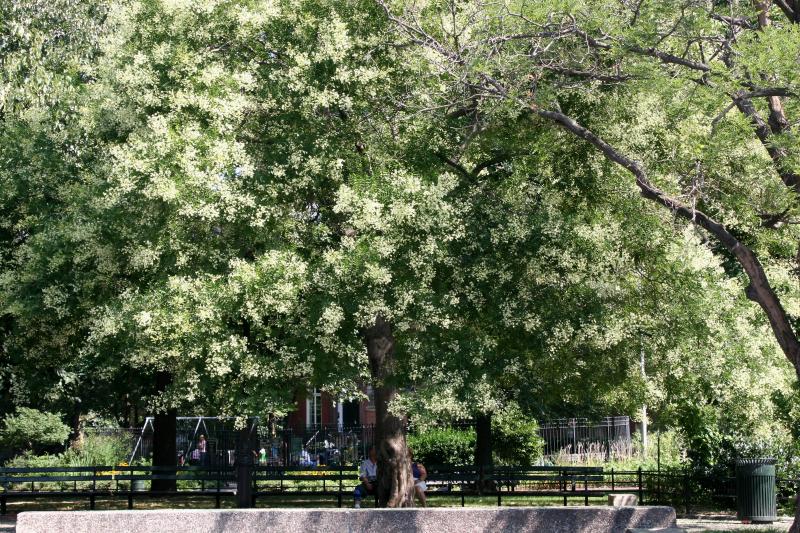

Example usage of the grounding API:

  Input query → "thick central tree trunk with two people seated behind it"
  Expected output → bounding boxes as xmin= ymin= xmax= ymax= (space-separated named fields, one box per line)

xmin=364 ymin=315 xmax=414 ymax=507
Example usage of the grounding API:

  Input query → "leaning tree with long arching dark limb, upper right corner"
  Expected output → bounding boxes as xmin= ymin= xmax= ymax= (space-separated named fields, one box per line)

xmin=384 ymin=1 xmax=800 ymax=520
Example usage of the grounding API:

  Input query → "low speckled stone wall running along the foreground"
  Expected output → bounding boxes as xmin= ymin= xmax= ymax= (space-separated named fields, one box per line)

xmin=17 ymin=506 xmax=675 ymax=533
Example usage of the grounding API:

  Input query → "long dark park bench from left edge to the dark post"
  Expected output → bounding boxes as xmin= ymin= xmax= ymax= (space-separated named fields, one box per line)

xmin=0 ymin=466 xmax=233 ymax=514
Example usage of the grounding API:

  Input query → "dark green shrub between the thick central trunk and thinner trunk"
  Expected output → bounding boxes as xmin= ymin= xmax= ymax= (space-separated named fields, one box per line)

xmin=407 ymin=428 xmax=475 ymax=465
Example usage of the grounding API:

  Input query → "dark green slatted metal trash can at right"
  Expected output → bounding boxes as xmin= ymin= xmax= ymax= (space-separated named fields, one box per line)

xmin=736 ymin=459 xmax=778 ymax=522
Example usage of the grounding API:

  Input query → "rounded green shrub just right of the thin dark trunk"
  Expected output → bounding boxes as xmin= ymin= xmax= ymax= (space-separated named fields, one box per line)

xmin=492 ymin=409 xmax=544 ymax=466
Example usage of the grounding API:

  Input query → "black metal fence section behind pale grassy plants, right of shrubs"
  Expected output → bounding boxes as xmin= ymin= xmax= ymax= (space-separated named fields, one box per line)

xmin=539 ymin=416 xmax=632 ymax=459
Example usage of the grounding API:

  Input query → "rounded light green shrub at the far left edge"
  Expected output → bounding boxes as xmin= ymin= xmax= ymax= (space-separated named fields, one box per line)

xmin=0 ymin=407 xmax=69 ymax=452
